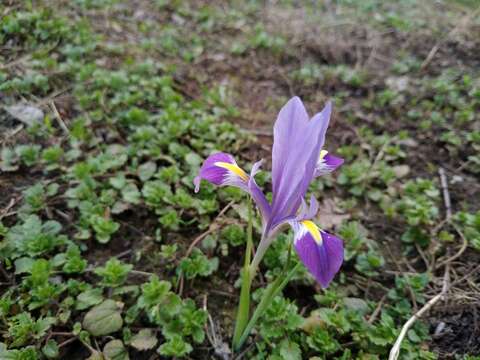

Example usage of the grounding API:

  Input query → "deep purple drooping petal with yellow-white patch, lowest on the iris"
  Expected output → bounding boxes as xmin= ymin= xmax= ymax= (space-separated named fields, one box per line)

xmin=290 ymin=220 xmax=343 ymax=288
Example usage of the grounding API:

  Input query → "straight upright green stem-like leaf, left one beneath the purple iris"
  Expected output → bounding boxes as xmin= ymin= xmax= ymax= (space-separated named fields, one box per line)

xmin=233 ymin=203 xmax=256 ymax=348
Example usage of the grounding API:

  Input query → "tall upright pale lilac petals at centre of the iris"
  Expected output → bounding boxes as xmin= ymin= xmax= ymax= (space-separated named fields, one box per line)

xmin=270 ymin=98 xmax=331 ymax=228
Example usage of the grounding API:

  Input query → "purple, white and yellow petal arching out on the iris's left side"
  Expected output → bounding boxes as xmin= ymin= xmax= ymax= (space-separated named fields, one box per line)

xmin=193 ymin=152 xmax=249 ymax=192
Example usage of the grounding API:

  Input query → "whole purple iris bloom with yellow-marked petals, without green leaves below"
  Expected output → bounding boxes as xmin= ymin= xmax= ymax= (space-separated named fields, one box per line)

xmin=194 ymin=97 xmax=343 ymax=288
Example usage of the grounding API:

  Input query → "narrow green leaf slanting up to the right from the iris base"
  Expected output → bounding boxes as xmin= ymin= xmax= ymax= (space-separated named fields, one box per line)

xmin=234 ymin=262 xmax=301 ymax=350
